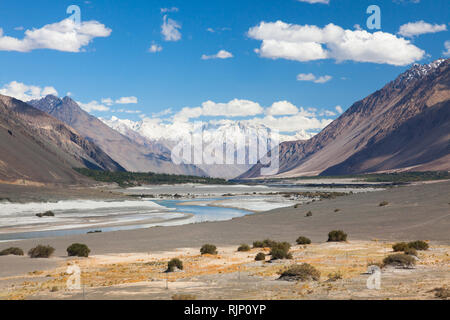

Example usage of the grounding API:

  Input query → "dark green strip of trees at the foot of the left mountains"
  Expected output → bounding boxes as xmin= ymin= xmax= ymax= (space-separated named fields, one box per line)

xmin=75 ymin=168 xmax=231 ymax=188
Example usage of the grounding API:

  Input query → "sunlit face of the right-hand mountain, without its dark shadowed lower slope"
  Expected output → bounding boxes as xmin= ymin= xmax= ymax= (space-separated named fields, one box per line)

xmin=239 ymin=59 xmax=450 ymax=178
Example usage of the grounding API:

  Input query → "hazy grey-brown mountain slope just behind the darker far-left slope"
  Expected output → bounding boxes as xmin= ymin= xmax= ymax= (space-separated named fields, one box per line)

xmin=29 ymin=95 xmax=206 ymax=176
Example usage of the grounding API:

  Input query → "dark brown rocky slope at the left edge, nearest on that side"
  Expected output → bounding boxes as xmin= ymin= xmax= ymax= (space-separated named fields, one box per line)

xmin=0 ymin=95 xmax=124 ymax=184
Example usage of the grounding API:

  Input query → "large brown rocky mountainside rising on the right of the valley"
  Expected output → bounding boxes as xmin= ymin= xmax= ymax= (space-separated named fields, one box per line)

xmin=240 ymin=59 xmax=450 ymax=178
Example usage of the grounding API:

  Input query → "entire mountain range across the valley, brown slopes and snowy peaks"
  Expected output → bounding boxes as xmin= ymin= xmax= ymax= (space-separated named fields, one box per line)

xmin=0 ymin=59 xmax=450 ymax=184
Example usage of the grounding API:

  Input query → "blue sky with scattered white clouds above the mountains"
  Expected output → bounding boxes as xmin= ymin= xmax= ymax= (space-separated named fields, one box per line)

xmin=0 ymin=0 xmax=450 ymax=133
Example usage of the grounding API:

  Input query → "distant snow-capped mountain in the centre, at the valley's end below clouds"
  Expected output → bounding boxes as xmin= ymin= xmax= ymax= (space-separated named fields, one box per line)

xmin=101 ymin=116 xmax=310 ymax=178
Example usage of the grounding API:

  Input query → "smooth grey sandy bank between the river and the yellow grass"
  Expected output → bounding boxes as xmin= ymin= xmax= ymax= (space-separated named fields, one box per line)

xmin=0 ymin=182 xmax=450 ymax=275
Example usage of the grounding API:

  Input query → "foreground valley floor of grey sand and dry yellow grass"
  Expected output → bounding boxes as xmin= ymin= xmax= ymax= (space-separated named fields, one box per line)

xmin=0 ymin=181 xmax=450 ymax=299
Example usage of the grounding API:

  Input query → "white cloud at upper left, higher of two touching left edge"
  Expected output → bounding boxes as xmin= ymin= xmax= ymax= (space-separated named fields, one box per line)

xmin=0 ymin=19 xmax=111 ymax=52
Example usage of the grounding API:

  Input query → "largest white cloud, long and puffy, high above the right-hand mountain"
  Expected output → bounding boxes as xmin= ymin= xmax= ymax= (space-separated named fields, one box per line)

xmin=247 ymin=21 xmax=425 ymax=66
